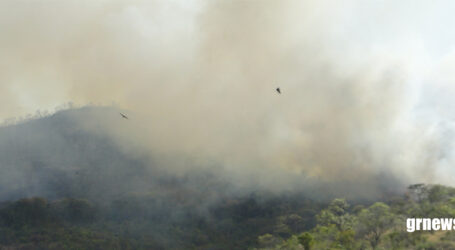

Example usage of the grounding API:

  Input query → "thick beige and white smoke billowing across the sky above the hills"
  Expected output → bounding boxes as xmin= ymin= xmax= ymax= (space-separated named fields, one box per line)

xmin=0 ymin=0 xmax=455 ymax=199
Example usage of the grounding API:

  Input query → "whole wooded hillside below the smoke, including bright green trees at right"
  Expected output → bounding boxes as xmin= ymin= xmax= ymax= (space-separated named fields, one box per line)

xmin=0 ymin=107 xmax=455 ymax=249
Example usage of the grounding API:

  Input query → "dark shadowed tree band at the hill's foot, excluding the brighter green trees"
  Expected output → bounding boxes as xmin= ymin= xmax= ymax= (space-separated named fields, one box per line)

xmin=0 ymin=194 xmax=319 ymax=249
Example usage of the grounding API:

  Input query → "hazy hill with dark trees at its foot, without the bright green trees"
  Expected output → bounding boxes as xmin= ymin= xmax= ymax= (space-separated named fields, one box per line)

xmin=0 ymin=107 xmax=320 ymax=249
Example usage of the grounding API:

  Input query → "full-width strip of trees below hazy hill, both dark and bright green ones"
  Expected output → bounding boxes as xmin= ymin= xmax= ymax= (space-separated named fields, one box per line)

xmin=0 ymin=185 xmax=455 ymax=250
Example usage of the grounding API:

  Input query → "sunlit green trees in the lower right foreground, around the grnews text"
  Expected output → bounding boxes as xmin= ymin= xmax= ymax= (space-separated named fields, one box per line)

xmin=256 ymin=184 xmax=455 ymax=250
